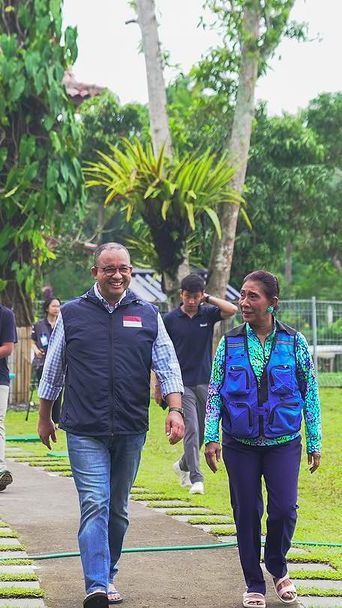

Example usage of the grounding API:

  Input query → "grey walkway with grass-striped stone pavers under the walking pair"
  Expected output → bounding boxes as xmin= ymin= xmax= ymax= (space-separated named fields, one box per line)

xmin=0 ymin=448 xmax=342 ymax=608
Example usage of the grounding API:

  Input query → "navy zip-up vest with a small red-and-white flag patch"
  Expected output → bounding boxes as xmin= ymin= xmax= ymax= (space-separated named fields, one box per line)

xmin=60 ymin=289 xmax=158 ymax=436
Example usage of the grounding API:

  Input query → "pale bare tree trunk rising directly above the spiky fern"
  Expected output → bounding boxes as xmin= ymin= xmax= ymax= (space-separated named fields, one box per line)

xmin=137 ymin=0 xmax=172 ymax=158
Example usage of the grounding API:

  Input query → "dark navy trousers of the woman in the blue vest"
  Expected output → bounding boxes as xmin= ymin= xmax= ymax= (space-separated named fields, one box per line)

xmin=223 ymin=437 xmax=301 ymax=594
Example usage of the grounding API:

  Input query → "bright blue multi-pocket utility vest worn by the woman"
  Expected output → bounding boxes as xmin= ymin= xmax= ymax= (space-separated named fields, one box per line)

xmin=220 ymin=321 xmax=304 ymax=439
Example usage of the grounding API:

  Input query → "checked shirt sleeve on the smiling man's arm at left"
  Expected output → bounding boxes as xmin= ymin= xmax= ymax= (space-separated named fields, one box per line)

xmin=38 ymin=313 xmax=66 ymax=401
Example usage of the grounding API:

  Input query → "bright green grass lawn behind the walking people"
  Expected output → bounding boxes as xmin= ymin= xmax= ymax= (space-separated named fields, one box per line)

xmin=6 ymin=389 xmax=342 ymax=567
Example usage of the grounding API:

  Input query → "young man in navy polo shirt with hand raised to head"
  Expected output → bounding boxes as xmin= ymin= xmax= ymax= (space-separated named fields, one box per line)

xmin=156 ymin=273 xmax=237 ymax=494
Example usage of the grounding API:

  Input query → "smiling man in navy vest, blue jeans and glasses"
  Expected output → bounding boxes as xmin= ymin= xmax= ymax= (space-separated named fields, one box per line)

xmin=38 ymin=243 xmax=184 ymax=608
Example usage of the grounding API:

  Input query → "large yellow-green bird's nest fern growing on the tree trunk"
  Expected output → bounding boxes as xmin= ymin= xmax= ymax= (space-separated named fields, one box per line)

xmin=85 ymin=140 xmax=248 ymax=294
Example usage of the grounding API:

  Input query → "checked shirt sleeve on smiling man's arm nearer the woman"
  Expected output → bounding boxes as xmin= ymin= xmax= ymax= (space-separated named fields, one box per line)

xmin=152 ymin=313 xmax=184 ymax=397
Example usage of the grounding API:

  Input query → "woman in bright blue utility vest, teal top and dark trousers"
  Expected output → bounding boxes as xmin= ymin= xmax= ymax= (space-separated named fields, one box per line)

xmin=205 ymin=270 xmax=321 ymax=608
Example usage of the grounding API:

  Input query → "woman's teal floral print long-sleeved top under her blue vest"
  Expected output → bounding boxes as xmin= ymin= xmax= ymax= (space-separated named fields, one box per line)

xmin=204 ymin=323 xmax=322 ymax=454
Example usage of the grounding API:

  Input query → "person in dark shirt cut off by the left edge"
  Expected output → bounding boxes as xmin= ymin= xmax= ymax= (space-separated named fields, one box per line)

xmin=0 ymin=304 xmax=17 ymax=492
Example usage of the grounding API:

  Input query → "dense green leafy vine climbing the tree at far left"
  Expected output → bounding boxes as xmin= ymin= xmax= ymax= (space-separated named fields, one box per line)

xmin=0 ymin=0 xmax=84 ymax=326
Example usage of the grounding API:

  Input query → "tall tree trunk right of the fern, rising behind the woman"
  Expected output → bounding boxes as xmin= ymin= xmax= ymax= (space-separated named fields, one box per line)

xmin=207 ymin=0 xmax=261 ymax=297
